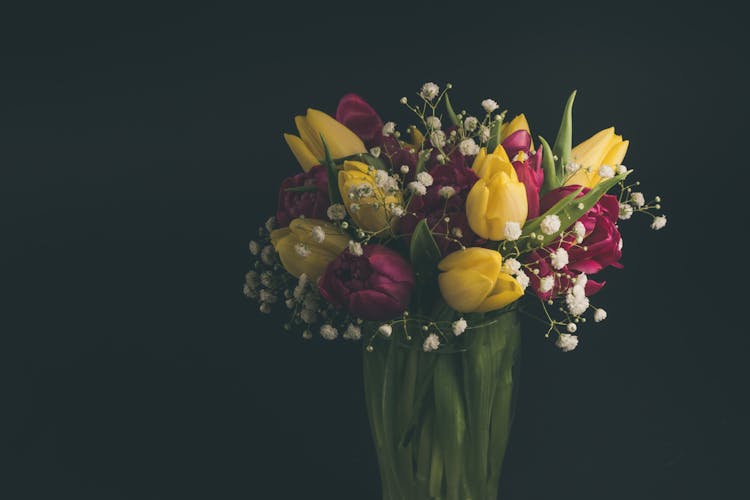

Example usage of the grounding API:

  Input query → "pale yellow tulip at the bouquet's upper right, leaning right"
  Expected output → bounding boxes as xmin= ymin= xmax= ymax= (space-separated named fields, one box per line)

xmin=565 ymin=127 xmax=630 ymax=188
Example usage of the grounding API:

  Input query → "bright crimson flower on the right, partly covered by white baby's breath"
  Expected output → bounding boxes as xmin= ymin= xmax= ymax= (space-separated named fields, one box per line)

xmin=526 ymin=186 xmax=622 ymax=300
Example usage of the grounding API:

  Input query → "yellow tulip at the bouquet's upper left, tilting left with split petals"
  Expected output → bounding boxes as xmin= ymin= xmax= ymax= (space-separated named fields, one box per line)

xmin=284 ymin=109 xmax=367 ymax=172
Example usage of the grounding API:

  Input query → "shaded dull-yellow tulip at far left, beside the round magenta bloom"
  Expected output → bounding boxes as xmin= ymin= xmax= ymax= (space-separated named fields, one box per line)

xmin=271 ymin=218 xmax=349 ymax=281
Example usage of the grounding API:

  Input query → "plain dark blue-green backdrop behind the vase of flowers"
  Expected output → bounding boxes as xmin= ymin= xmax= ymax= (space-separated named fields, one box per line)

xmin=0 ymin=2 xmax=748 ymax=499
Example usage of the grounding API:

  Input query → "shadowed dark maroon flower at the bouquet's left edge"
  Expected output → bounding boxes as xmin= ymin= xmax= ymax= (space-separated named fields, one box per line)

xmin=276 ymin=165 xmax=329 ymax=227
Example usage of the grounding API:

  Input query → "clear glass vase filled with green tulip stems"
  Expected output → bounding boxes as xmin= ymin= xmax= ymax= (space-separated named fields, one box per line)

xmin=364 ymin=307 xmax=521 ymax=500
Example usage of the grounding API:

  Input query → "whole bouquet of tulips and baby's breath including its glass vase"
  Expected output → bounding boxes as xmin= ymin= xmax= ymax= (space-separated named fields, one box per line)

xmin=244 ymin=83 xmax=666 ymax=500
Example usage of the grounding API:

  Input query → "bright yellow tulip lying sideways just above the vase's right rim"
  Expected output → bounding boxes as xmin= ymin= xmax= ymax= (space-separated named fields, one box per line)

xmin=438 ymin=247 xmax=523 ymax=313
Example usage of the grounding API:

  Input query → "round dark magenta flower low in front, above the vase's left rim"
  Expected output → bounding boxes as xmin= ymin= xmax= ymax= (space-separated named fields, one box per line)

xmin=318 ymin=245 xmax=415 ymax=321
